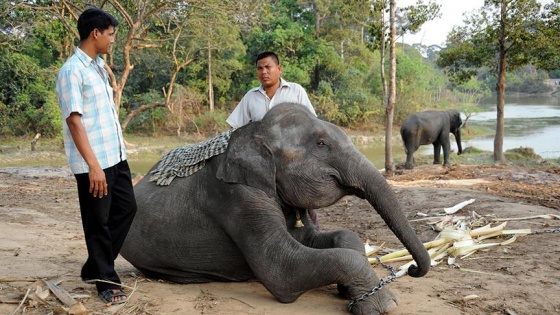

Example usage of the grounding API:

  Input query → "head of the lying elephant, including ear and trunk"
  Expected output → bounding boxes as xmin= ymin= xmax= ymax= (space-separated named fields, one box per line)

xmin=218 ymin=104 xmax=430 ymax=277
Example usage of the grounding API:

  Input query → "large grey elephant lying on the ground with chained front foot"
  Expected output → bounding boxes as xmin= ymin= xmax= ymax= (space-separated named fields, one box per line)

xmin=121 ymin=104 xmax=430 ymax=314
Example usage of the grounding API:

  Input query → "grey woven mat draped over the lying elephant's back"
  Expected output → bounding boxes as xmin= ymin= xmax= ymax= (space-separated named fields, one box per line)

xmin=150 ymin=129 xmax=233 ymax=186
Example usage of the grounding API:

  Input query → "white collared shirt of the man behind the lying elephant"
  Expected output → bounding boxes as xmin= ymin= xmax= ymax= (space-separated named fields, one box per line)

xmin=226 ymin=78 xmax=317 ymax=128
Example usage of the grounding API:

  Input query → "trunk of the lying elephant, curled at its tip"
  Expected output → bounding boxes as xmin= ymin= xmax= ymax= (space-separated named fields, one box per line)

xmin=344 ymin=155 xmax=431 ymax=277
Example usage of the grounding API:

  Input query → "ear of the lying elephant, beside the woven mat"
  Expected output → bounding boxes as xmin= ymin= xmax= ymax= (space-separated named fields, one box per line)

xmin=216 ymin=121 xmax=276 ymax=197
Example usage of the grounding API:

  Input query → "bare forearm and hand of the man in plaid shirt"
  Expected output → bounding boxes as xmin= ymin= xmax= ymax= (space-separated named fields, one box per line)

xmin=66 ymin=112 xmax=108 ymax=198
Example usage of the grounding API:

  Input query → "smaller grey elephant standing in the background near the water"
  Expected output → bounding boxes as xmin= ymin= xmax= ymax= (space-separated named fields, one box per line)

xmin=401 ymin=109 xmax=463 ymax=169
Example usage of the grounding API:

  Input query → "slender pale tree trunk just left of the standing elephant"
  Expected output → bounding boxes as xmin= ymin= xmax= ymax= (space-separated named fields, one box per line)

xmin=385 ymin=0 xmax=397 ymax=176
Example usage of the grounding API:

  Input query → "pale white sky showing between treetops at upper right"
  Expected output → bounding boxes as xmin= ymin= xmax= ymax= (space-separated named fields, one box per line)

xmin=397 ymin=0 xmax=484 ymax=46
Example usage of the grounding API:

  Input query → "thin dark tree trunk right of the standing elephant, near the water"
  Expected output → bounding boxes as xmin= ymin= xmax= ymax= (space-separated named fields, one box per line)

xmin=494 ymin=2 xmax=507 ymax=164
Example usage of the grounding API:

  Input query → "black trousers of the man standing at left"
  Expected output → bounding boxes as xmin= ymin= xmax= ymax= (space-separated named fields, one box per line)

xmin=75 ymin=161 xmax=136 ymax=292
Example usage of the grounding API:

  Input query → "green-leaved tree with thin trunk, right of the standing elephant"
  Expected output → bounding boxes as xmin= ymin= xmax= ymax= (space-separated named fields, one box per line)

xmin=437 ymin=0 xmax=541 ymax=164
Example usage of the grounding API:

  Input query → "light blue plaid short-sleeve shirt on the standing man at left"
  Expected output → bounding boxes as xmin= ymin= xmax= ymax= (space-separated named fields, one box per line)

xmin=56 ymin=48 xmax=126 ymax=174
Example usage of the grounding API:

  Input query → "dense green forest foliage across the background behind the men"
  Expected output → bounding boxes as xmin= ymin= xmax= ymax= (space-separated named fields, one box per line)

xmin=0 ymin=0 xmax=560 ymax=137
